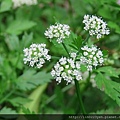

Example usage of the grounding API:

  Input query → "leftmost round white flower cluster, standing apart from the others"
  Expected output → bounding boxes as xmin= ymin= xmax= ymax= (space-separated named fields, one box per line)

xmin=23 ymin=44 xmax=51 ymax=68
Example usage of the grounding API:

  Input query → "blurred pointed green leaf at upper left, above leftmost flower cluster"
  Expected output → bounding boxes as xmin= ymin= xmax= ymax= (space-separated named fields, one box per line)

xmin=6 ymin=20 xmax=36 ymax=35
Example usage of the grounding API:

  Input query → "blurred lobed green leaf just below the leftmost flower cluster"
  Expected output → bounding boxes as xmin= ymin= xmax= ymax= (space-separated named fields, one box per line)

xmin=16 ymin=70 xmax=52 ymax=91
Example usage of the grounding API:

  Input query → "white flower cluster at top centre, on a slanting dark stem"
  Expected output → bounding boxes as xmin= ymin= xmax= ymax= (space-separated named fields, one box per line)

xmin=44 ymin=23 xmax=70 ymax=43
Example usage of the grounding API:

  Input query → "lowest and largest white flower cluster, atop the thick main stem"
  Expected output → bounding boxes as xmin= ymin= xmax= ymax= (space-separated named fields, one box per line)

xmin=51 ymin=53 xmax=82 ymax=84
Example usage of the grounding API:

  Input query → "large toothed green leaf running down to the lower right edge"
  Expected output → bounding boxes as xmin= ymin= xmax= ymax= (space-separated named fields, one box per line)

xmin=95 ymin=73 xmax=120 ymax=106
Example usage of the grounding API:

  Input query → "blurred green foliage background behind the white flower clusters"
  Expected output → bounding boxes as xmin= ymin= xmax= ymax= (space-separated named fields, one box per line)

xmin=0 ymin=0 xmax=120 ymax=114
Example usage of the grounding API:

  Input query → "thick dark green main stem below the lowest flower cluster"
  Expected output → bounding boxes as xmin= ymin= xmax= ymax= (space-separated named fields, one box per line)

xmin=74 ymin=80 xmax=86 ymax=114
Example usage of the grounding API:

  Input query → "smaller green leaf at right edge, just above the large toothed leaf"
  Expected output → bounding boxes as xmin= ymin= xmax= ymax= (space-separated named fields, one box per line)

xmin=97 ymin=66 xmax=120 ymax=77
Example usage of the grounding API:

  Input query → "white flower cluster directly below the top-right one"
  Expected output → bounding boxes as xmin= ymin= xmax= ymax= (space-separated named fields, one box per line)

xmin=80 ymin=45 xmax=104 ymax=71
